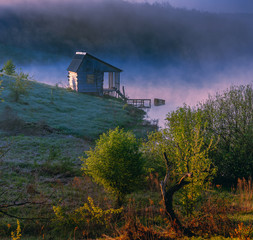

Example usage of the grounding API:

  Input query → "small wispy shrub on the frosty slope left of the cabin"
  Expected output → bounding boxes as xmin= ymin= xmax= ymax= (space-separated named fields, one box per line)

xmin=9 ymin=71 xmax=32 ymax=102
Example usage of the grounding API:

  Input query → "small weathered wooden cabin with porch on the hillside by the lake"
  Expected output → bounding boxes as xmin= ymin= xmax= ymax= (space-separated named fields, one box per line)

xmin=67 ymin=52 xmax=122 ymax=96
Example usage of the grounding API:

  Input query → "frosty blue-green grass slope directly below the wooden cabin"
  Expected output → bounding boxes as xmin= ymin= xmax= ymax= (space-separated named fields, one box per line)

xmin=0 ymin=76 xmax=148 ymax=139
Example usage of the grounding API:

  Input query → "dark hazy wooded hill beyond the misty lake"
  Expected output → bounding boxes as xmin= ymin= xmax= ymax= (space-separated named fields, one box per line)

xmin=0 ymin=0 xmax=253 ymax=67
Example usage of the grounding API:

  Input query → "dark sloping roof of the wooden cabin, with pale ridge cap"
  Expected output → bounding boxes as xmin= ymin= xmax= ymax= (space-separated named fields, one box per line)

xmin=67 ymin=52 xmax=122 ymax=72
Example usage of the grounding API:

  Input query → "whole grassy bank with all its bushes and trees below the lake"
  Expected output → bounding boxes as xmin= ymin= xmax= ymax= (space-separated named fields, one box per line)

xmin=0 ymin=62 xmax=253 ymax=240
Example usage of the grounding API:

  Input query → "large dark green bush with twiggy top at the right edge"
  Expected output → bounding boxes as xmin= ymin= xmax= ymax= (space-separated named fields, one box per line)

xmin=198 ymin=85 xmax=253 ymax=184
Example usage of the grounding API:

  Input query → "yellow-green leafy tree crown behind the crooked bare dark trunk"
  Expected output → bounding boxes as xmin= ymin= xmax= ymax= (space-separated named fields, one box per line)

xmin=143 ymin=106 xmax=215 ymax=214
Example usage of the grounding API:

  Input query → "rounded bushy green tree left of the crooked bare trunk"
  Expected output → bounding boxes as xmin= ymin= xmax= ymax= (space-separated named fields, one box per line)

xmin=82 ymin=128 xmax=143 ymax=206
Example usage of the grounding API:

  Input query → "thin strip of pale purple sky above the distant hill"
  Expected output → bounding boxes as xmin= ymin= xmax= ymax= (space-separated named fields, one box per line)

xmin=0 ymin=0 xmax=253 ymax=13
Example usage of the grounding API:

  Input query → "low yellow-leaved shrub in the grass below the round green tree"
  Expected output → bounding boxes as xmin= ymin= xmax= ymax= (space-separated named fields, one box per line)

xmin=53 ymin=197 xmax=123 ymax=237
